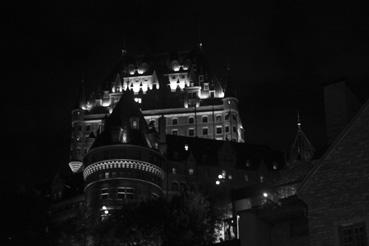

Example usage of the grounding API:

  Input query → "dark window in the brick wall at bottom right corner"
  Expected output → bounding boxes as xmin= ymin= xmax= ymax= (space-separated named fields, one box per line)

xmin=339 ymin=222 xmax=368 ymax=246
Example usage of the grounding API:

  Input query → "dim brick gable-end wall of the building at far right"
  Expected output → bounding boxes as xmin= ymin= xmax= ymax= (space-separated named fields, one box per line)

xmin=299 ymin=103 xmax=369 ymax=246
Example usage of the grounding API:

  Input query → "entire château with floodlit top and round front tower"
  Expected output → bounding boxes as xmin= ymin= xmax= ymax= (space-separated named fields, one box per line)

xmin=50 ymin=45 xmax=284 ymax=245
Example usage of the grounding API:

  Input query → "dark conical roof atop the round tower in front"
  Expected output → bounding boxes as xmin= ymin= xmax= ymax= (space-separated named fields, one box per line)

xmin=91 ymin=91 xmax=154 ymax=149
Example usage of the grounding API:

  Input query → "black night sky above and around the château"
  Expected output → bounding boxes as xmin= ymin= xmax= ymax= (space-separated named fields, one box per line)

xmin=3 ymin=0 xmax=369 ymax=186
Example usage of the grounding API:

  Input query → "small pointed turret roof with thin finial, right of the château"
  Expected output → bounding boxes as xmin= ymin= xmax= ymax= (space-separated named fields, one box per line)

xmin=289 ymin=112 xmax=315 ymax=163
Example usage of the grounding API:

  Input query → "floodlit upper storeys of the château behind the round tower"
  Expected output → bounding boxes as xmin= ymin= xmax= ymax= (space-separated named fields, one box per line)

xmin=71 ymin=47 xmax=245 ymax=169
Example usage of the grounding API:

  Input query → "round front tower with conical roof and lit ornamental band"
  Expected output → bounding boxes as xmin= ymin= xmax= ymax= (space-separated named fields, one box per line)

xmin=83 ymin=92 xmax=164 ymax=222
